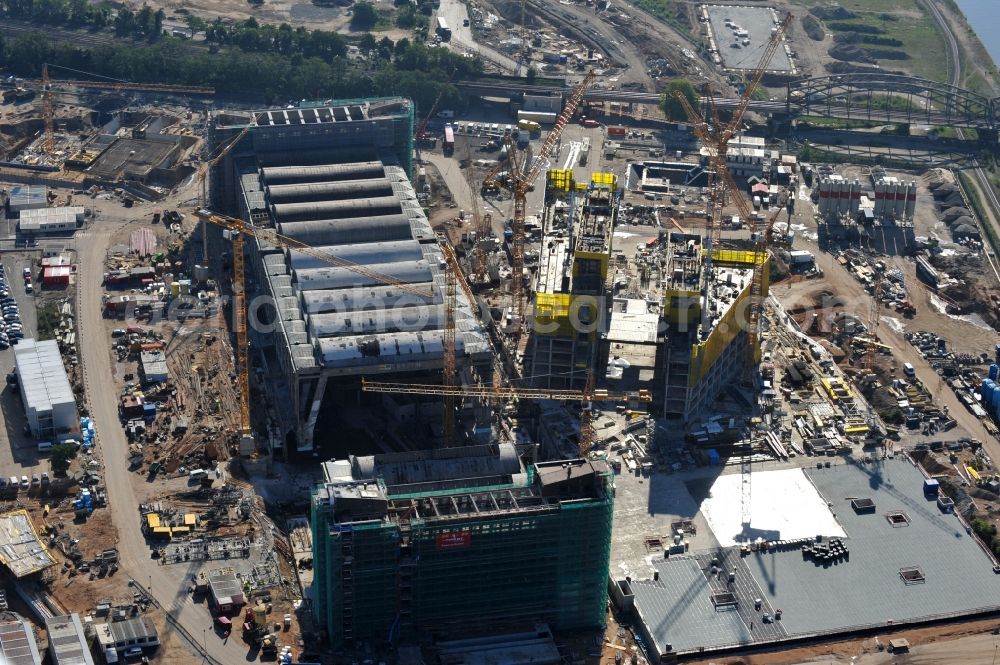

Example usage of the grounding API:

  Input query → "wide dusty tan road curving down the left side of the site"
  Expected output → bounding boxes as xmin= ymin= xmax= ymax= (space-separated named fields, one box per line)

xmin=77 ymin=219 xmax=252 ymax=665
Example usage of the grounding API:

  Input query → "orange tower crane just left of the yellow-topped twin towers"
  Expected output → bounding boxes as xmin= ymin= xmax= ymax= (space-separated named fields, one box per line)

xmin=483 ymin=70 xmax=597 ymax=341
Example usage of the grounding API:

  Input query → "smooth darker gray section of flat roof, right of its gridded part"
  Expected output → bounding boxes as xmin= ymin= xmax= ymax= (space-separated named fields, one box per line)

xmin=746 ymin=457 xmax=1000 ymax=633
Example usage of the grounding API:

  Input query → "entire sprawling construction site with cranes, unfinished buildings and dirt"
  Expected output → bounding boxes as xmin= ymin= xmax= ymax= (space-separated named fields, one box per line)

xmin=0 ymin=2 xmax=1000 ymax=665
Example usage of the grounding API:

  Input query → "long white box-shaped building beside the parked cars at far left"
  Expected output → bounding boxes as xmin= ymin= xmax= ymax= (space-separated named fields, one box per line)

xmin=14 ymin=338 xmax=79 ymax=438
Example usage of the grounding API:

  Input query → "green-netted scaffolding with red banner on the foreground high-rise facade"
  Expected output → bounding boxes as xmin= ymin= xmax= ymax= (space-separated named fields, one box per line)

xmin=312 ymin=469 xmax=613 ymax=645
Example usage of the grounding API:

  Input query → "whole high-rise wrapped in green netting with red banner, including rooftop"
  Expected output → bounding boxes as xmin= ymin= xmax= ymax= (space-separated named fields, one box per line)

xmin=312 ymin=444 xmax=614 ymax=645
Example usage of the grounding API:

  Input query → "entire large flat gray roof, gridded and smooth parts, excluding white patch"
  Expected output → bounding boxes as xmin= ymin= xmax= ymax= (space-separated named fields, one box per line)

xmin=632 ymin=457 xmax=1000 ymax=653
